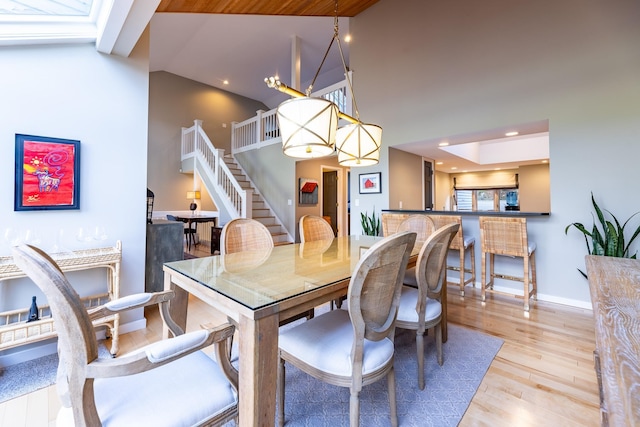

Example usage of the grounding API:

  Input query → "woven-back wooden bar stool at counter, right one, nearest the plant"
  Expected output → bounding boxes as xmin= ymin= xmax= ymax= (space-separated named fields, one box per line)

xmin=479 ymin=216 xmax=538 ymax=311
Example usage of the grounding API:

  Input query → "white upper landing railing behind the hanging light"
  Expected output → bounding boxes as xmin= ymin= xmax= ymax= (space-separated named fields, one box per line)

xmin=231 ymin=71 xmax=353 ymax=154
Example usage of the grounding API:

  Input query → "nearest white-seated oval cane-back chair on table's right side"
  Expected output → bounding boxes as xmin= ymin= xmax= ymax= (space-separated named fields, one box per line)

xmin=277 ymin=232 xmax=416 ymax=427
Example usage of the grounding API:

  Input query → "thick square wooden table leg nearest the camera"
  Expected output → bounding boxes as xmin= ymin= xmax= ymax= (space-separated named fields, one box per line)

xmin=239 ymin=316 xmax=278 ymax=427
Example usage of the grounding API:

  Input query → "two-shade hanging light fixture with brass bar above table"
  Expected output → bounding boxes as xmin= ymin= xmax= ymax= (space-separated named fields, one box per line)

xmin=264 ymin=0 xmax=382 ymax=166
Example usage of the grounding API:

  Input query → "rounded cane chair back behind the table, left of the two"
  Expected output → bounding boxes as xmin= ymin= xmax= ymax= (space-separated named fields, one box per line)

xmin=220 ymin=218 xmax=273 ymax=255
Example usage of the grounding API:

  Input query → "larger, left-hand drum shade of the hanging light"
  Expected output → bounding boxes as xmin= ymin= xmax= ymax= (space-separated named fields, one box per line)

xmin=276 ymin=97 xmax=338 ymax=159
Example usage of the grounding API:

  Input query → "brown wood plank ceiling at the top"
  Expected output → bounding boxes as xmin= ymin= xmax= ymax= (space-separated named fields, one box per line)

xmin=156 ymin=0 xmax=378 ymax=17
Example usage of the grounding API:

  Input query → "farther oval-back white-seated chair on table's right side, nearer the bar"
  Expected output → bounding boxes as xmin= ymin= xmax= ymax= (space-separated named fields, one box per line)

xmin=396 ymin=224 xmax=460 ymax=390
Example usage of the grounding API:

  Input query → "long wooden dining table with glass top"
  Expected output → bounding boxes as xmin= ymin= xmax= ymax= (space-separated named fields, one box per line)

xmin=163 ymin=235 xmax=446 ymax=427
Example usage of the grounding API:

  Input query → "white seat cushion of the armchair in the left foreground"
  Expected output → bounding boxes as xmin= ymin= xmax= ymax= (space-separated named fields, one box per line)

xmin=94 ymin=351 xmax=237 ymax=427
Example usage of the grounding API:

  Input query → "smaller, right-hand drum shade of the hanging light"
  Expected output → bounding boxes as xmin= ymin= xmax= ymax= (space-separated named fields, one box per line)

xmin=336 ymin=123 xmax=382 ymax=166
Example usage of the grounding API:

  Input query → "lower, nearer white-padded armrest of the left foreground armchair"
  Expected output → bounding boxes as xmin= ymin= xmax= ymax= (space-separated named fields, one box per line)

xmin=86 ymin=323 xmax=237 ymax=382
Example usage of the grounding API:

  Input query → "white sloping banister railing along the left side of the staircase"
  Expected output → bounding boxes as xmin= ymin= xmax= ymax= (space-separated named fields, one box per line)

xmin=182 ymin=120 xmax=253 ymax=218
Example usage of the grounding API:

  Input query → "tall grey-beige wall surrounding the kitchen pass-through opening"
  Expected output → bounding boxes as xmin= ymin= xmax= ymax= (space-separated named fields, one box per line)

xmin=350 ymin=0 xmax=640 ymax=306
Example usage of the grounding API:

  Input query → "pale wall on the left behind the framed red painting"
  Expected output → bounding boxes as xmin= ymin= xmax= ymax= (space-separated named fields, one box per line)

xmin=0 ymin=34 xmax=149 ymax=362
